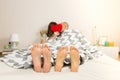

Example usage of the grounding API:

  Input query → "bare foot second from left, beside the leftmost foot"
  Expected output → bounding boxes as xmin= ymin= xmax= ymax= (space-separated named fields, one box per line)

xmin=43 ymin=45 xmax=52 ymax=73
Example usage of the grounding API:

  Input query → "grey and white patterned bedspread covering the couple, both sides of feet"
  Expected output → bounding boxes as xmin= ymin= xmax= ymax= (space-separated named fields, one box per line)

xmin=0 ymin=30 xmax=101 ymax=69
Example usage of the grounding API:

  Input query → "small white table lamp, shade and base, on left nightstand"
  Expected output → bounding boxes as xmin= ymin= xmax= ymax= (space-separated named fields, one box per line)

xmin=10 ymin=33 xmax=19 ymax=49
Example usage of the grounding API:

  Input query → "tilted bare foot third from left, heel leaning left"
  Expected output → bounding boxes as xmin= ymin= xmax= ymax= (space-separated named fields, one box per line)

xmin=55 ymin=46 xmax=68 ymax=72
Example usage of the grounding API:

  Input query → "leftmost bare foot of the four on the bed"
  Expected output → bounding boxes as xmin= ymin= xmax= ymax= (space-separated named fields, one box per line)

xmin=31 ymin=44 xmax=42 ymax=72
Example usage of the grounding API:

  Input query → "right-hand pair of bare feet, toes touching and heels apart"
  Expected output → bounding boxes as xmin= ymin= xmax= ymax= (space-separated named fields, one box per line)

xmin=55 ymin=46 xmax=80 ymax=72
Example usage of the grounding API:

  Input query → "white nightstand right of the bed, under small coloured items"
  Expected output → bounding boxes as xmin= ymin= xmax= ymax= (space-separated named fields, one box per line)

xmin=98 ymin=46 xmax=119 ymax=59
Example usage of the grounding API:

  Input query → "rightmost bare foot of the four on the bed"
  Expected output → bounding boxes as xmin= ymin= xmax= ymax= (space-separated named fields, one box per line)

xmin=70 ymin=46 xmax=80 ymax=72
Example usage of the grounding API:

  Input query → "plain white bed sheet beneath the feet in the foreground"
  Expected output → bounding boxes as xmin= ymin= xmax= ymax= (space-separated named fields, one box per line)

xmin=0 ymin=55 xmax=120 ymax=80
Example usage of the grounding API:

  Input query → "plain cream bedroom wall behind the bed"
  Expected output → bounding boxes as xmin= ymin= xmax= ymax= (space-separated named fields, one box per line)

xmin=0 ymin=0 xmax=120 ymax=49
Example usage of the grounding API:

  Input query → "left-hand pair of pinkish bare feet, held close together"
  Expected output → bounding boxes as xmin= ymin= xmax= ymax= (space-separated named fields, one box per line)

xmin=31 ymin=44 xmax=51 ymax=73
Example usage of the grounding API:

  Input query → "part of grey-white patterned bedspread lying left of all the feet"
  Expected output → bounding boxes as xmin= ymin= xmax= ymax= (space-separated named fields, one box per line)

xmin=0 ymin=46 xmax=32 ymax=69
